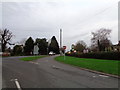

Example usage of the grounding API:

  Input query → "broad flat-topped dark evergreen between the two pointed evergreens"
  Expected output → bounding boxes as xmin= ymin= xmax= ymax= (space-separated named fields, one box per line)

xmin=35 ymin=38 xmax=48 ymax=55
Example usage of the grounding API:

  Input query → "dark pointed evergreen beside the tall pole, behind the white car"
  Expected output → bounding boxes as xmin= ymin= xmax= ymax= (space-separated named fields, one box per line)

xmin=49 ymin=36 xmax=60 ymax=54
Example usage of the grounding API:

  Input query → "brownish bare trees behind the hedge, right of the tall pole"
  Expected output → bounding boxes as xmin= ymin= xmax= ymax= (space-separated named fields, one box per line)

xmin=71 ymin=28 xmax=112 ymax=52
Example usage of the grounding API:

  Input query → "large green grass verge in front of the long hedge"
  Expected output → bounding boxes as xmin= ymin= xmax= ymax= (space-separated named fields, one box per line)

xmin=55 ymin=56 xmax=120 ymax=76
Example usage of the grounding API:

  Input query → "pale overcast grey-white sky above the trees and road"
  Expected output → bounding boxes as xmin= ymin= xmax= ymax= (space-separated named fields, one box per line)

xmin=0 ymin=0 xmax=120 ymax=50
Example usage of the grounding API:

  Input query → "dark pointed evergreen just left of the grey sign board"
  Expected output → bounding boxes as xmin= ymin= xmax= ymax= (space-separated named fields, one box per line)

xmin=24 ymin=37 xmax=34 ymax=55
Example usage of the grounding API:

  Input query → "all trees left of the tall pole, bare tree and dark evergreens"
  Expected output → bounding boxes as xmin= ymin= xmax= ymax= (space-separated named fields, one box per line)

xmin=0 ymin=29 xmax=59 ymax=55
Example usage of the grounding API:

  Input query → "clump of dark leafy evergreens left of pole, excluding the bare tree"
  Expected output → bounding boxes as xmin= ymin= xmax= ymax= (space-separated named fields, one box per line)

xmin=13 ymin=36 xmax=59 ymax=55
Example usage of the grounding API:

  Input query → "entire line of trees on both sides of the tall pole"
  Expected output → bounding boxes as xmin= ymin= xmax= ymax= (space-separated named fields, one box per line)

xmin=0 ymin=28 xmax=115 ymax=55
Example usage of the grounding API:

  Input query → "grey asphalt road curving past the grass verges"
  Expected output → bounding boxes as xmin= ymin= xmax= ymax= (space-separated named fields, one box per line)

xmin=2 ymin=56 xmax=118 ymax=88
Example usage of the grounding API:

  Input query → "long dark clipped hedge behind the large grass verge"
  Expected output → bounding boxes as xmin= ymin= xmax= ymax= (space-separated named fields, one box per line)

xmin=66 ymin=52 xmax=120 ymax=60
